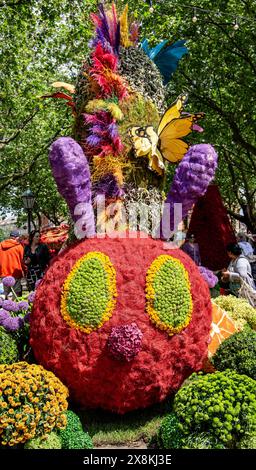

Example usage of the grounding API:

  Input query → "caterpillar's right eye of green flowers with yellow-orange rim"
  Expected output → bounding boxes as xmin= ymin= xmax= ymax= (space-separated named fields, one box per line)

xmin=146 ymin=255 xmax=193 ymax=336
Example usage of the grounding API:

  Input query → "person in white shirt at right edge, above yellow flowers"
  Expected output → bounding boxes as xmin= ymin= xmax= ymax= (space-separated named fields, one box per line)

xmin=221 ymin=243 xmax=255 ymax=295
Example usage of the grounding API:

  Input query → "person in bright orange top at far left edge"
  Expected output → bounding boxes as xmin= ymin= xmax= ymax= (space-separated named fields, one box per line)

xmin=0 ymin=230 xmax=24 ymax=299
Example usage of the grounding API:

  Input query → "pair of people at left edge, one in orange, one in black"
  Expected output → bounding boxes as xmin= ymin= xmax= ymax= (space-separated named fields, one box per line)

xmin=0 ymin=230 xmax=50 ymax=298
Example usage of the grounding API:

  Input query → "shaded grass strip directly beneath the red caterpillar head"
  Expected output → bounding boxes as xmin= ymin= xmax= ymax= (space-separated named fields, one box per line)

xmin=74 ymin=398 xmax=172 ymax=447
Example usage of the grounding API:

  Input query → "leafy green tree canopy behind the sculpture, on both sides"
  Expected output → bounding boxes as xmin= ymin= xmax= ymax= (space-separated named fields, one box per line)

xmin=0 ymin=0 xmax=256 ymax=233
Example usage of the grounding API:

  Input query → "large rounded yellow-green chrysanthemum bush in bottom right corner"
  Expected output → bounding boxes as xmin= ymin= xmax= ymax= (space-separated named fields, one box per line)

xmin=174 ymin=370 xmax=256 ymax=447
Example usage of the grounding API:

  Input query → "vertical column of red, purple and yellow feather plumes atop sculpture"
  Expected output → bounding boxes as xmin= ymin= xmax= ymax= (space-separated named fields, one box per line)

xmin=84 ymin=4 xmax=128 ymax=174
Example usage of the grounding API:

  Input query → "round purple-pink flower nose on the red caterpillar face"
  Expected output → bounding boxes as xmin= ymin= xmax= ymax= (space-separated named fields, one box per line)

xmin=108 ymin=323 xmax=143 ymax=362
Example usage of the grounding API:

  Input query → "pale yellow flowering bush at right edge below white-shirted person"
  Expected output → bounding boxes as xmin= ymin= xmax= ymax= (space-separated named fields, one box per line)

xmin=214 ymin=295 xmax=256 ymax=329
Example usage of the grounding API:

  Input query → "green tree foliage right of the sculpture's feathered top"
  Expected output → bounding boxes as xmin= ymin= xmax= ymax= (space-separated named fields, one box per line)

xmin=121 ymin=0 xmax=256 ymax=232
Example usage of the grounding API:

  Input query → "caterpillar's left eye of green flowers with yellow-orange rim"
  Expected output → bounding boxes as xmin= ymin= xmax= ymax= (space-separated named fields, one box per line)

xmin=61 ymin=251 xmax=117 ymax=333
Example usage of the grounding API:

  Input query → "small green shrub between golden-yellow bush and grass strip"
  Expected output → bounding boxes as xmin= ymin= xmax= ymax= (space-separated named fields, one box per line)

xmin=59 ymin=410 xmax=93 ymax=449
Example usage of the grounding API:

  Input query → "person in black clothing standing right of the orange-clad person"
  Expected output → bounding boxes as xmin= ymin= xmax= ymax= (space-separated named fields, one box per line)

xmin=24 ymin=230 xmax=50 ymax=291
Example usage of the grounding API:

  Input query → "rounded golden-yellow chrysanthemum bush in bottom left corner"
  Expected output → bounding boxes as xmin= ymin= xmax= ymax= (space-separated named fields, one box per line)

xmin=0 ymin=362 xmax=68 ymax=446
